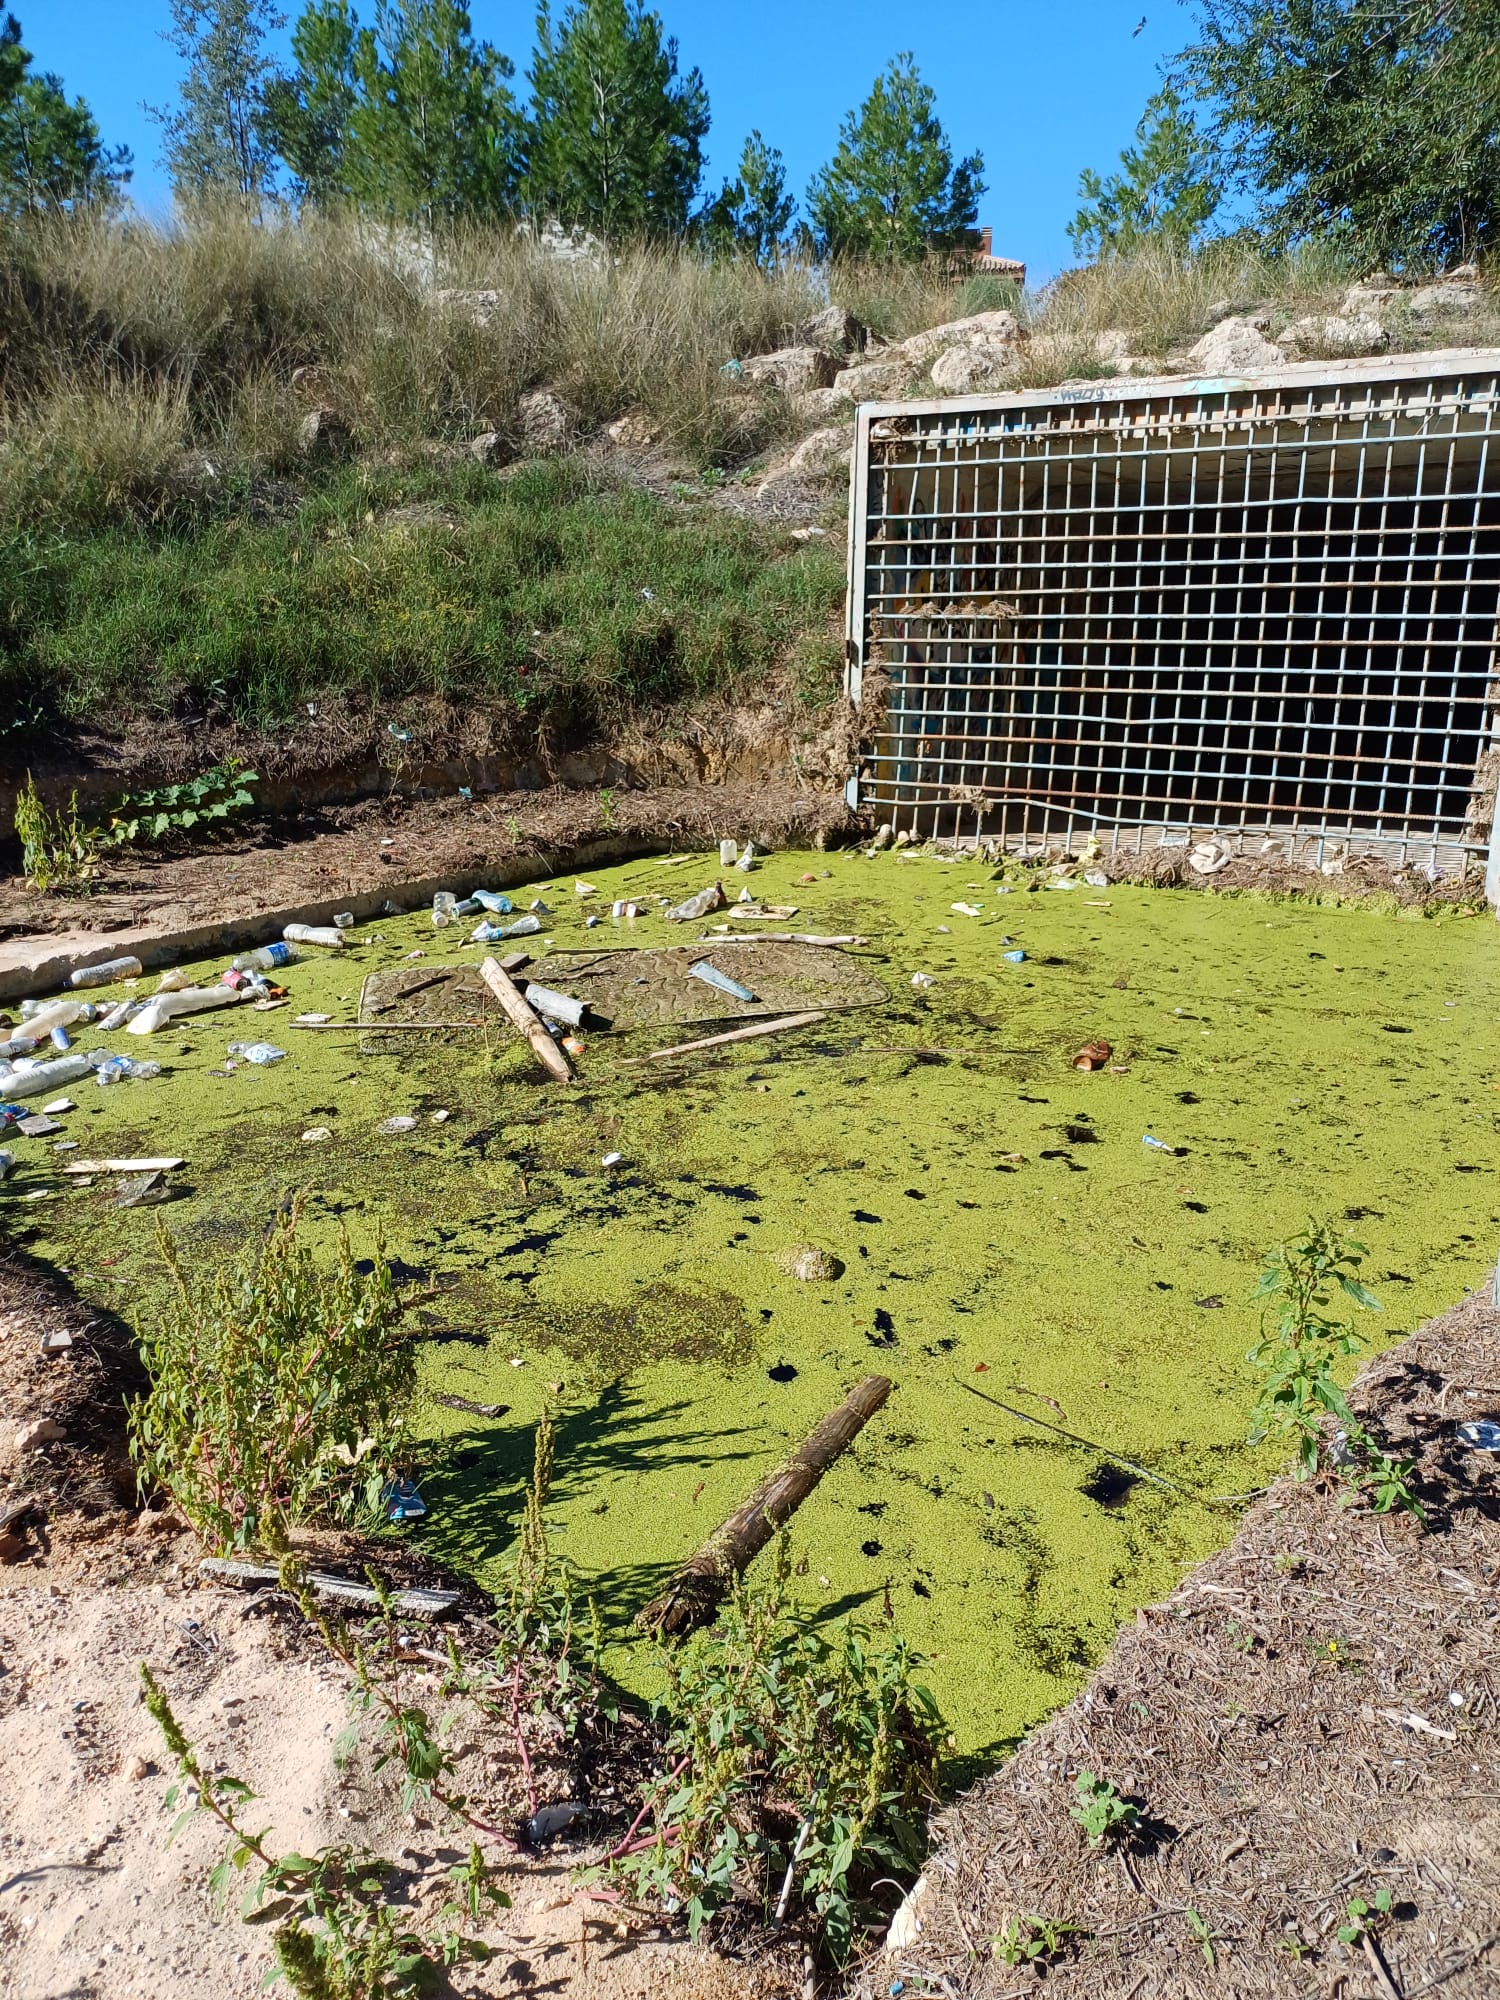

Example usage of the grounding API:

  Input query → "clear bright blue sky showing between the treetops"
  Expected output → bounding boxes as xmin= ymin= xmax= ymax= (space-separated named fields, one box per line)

xmin=23 ymin=0 xmax=1192 ymax=280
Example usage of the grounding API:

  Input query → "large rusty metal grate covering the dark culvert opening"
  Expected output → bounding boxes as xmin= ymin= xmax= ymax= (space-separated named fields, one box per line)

xmin=850 ymin=352 xmax=1500 ymax=884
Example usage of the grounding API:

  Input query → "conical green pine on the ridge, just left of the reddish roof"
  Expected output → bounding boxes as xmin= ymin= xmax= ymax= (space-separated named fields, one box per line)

xmin=808 ymin=54 xmax=984 ymax=260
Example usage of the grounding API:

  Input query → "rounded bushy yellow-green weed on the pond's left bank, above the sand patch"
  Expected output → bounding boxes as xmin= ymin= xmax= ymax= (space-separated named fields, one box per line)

xmin=128 ymin=1194 xmax=416 ymax=1548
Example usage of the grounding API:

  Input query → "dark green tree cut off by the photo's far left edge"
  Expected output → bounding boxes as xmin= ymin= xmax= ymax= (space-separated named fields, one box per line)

xmin=0 ymin=14 xmax=130 ymax=216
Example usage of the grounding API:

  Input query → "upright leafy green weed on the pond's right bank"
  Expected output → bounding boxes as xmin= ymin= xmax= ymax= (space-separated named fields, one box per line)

xmin=1246 ymin=1222 xmax=1424 ymax=1522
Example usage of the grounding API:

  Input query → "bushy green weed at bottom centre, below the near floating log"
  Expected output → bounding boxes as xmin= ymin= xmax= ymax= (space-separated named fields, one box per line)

xmin=606 ymin=1536 xmax=946 ymax=1964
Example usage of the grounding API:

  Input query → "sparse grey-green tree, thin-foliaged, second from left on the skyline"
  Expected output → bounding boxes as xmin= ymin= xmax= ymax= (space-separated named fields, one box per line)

xmin=150 ymin=0 xmax=286 ymax=204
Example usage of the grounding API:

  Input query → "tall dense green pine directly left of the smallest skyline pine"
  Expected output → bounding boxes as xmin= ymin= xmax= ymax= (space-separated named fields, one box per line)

xmin=526 ymin=0 xmax=708 ymax=238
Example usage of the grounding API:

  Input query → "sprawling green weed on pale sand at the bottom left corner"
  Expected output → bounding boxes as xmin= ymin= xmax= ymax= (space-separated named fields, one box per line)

xmin=140 ymin=1664 xmax=510 ymax=2000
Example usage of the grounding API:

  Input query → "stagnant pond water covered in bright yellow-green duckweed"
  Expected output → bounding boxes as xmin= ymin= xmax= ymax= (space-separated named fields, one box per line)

xmin=6 ymin=854 xmax=1500 ymax=1750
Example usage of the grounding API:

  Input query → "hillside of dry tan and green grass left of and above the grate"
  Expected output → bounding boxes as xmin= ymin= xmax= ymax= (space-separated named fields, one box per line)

xmin=0 ymin=216 xmax=1494 ymax=764
